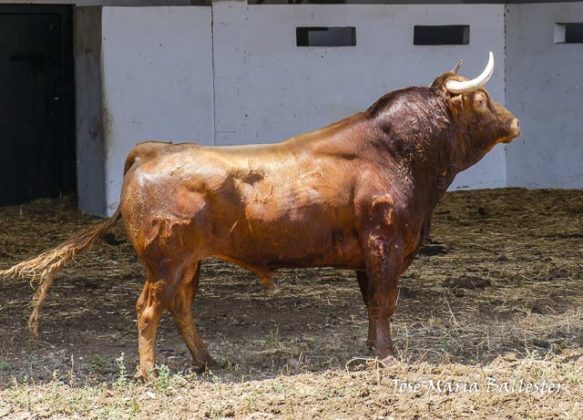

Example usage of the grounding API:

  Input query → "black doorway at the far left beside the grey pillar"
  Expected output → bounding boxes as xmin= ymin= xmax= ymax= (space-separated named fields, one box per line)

xmin=0 ymin=5 xmax=76 ymax=205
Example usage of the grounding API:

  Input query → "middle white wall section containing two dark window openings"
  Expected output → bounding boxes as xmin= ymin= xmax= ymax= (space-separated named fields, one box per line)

xmin=213 ymin=1 xmax=506 ymax=188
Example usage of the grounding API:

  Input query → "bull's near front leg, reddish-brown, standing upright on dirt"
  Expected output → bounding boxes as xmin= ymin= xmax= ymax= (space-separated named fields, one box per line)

xmin=359 ymin=229 xmax=405 ymax=364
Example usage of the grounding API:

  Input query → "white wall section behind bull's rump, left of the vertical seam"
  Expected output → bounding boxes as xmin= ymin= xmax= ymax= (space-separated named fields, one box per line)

xmin=101 ymin=6 xmax=214 ymax=214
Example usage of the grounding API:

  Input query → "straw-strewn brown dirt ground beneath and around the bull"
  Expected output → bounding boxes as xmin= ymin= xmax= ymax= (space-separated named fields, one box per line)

xmin=0 ymin=189 xmax=583 ymax=418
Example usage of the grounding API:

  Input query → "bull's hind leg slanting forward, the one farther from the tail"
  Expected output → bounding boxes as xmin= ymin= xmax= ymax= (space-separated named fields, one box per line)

xmin=169 ymin=262 xmax=215 ymax=369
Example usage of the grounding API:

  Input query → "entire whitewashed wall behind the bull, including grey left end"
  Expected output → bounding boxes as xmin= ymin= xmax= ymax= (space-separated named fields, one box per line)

xmin=76 ymin=1 xmax=583 ymax=214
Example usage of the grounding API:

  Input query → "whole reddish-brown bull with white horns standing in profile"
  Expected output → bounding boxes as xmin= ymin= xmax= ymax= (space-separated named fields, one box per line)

xmin=0 ymin=53 xmax=519 ymax=376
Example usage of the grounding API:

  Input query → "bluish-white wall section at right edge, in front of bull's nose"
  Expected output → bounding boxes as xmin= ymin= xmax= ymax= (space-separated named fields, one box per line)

xmin=506 ymin=3 xmax=583 ymax=188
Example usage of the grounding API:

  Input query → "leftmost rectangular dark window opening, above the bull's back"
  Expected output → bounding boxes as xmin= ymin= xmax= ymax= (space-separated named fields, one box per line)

xmin=296 ymin=26 xmax=356 ymax=47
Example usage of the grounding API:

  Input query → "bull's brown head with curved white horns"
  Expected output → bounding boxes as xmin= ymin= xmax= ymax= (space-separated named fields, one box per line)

xmin=432 ymin=52 xmax=520 ymax=164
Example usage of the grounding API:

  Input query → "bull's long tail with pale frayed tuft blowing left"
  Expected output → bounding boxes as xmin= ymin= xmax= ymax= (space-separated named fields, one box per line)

xmin=0 ymin=208 xmax=120 ymax=336
